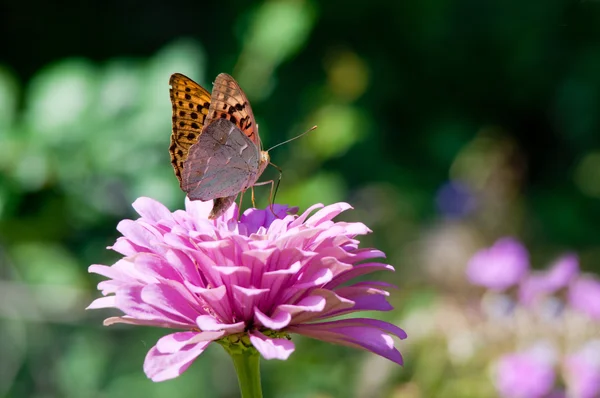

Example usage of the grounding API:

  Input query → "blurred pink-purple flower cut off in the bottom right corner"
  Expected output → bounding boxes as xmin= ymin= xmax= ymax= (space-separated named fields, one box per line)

xmin=564 ymin=340 xmax=600 ymax=398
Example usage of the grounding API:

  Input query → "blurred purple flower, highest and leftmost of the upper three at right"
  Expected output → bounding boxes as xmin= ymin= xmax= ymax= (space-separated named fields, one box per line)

xmin=466 ymin=238 xmax=529 ymax=291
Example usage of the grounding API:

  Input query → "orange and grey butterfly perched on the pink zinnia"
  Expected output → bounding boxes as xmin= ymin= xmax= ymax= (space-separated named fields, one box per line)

xmin=169 ymin=73 xmax=269 ymax=219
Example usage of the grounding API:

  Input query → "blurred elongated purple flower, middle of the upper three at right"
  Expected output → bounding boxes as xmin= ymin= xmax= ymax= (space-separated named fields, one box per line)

xmin=519 ymin=253 xmax=579 ymax=305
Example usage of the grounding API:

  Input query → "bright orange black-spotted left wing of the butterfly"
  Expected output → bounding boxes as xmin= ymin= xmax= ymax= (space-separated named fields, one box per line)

xmin=169 ymin=73 xmax=212 ymax=183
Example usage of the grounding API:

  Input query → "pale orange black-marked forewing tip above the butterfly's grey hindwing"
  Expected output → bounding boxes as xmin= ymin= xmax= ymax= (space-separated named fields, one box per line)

xmin=206 ymin=73 xmax=260 ymax=150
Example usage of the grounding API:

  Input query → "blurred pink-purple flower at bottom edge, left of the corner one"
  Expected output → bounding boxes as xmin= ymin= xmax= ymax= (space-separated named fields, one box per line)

xmin=496 ymin=349 xmax=555 ymax=398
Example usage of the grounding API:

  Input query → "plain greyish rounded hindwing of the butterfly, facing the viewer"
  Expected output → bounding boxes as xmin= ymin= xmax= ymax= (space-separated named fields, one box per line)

xmin=181 ymin=119 xmax=260 ymax=201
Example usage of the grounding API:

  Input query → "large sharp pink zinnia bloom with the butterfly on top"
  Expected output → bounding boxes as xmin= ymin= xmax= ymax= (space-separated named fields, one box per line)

xmin=88 ymin=198 xmax=406 ymax=381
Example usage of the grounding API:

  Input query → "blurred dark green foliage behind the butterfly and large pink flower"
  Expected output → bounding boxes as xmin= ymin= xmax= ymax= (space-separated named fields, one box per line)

xmin=0 ymin=0 xmax=600 ymax=398
